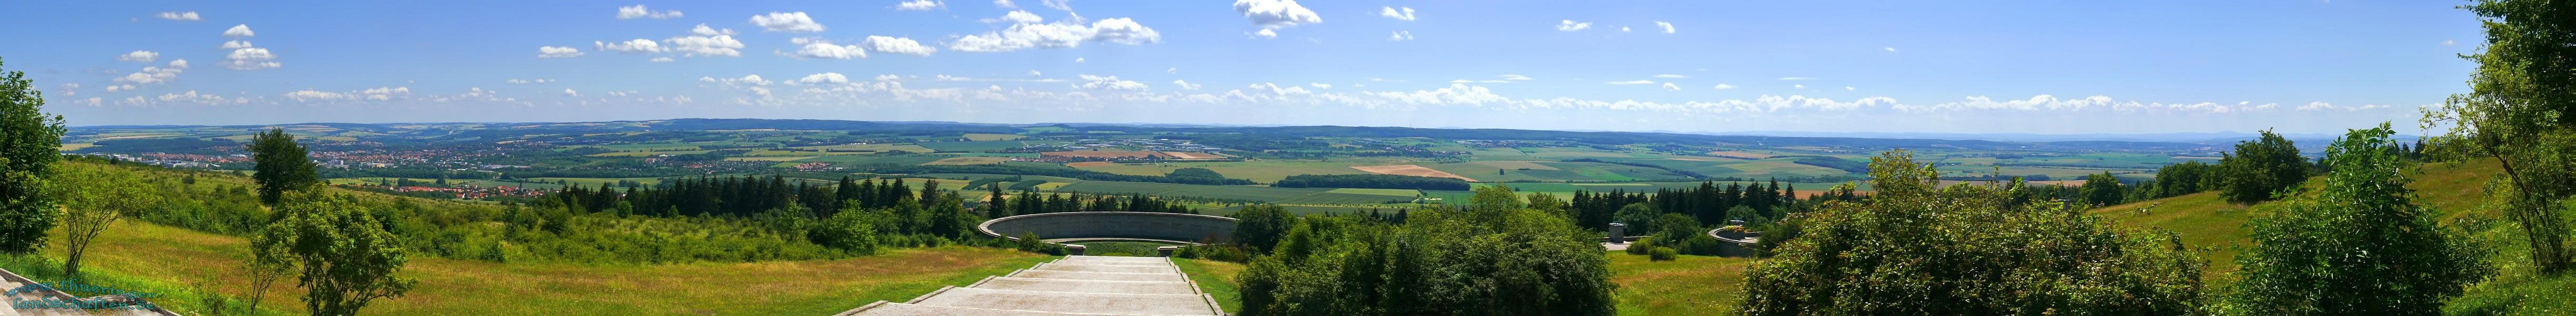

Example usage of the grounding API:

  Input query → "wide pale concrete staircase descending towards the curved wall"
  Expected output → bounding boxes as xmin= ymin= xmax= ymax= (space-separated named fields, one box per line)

xmin=834 ymin=254 xmax=1224 ymax=316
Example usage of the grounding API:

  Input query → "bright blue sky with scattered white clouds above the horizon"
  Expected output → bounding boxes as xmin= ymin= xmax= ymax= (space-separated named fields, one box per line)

xmin=0 ymin=0 xmax=2481 ymax=134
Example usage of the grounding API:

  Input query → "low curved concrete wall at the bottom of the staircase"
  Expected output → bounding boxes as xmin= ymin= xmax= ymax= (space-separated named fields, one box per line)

xmin=976 ymin=211 xmax=1234 ymax=244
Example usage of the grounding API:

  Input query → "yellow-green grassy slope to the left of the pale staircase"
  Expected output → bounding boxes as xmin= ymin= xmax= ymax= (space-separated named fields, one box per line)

xmin=43 ymin=223 xmax=1046 ymax=316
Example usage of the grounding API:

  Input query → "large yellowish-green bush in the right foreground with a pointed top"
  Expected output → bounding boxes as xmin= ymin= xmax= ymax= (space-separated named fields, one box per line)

xmin=1739 ymin=152 xmax=2205 ymax=316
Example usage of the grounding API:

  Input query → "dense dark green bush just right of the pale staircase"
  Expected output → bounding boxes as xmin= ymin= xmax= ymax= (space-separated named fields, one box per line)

xmin=1237 ymin=185 xmax=1613 ymax=316
